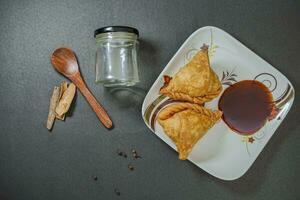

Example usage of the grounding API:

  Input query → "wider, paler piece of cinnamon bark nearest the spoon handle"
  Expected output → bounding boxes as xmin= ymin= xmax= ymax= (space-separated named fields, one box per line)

xmin=55 ymin=83 xmax=76 ymax=116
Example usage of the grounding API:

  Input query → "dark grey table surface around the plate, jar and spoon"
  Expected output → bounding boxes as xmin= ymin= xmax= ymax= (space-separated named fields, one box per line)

xmin=0 ymin=0 xmax=300 ymax=200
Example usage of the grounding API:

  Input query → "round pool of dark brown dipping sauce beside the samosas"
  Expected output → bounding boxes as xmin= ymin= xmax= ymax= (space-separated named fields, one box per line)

xmin=219 ymin=80 xmax=274 ymax=135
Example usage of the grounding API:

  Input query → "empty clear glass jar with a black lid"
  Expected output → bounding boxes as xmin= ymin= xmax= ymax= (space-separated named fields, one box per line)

xmin=95 ymin=26 xmax=139 ymax=87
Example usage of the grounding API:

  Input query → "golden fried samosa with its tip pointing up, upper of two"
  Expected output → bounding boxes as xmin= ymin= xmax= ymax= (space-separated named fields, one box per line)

xmin=160 ymin=45 xmax=222 ymax=104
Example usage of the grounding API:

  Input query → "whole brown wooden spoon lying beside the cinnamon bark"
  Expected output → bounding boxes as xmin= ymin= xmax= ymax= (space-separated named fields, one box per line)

xmin=51 ymin=48 xmax=113 ymax=128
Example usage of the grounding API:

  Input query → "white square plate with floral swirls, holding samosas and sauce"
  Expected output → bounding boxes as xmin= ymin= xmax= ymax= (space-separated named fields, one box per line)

xmin=142 ymin=26 xmax=294 ymax=180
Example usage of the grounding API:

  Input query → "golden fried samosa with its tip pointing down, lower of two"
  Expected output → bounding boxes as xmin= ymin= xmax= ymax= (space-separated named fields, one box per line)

xmin=158 ymin=103 xmax=222 ymax=160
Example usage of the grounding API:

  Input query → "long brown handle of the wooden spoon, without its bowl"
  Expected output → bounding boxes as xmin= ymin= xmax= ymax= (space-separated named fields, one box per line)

xmin=71 ymin=74 xmax=113 ymax=128
